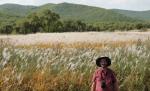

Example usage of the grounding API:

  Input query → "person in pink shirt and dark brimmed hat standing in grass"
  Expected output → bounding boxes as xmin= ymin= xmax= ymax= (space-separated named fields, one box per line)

xmin=91 ymin=57 xmax=119 ymax=91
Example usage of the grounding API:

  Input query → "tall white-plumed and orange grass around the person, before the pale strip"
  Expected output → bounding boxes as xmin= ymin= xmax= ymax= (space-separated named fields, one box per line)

xmin=0 ymin=32 xmax=150 ymax=91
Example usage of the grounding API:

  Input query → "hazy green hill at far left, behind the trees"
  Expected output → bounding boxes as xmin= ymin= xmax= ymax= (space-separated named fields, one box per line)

xmin=0 ymin=4 xmax=37 ymax=24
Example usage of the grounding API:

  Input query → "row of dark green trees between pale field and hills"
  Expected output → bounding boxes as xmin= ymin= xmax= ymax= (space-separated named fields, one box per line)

xmin=0 ymin=10 xmax=150 ymax=34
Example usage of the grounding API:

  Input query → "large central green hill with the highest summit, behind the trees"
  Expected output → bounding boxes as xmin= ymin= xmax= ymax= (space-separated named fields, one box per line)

xmin=39 ymin=3 xmax=139 ymax=23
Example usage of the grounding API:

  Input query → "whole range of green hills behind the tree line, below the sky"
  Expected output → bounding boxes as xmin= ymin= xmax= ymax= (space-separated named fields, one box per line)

xmin=0 ymin=3 xmax=150 ymax=23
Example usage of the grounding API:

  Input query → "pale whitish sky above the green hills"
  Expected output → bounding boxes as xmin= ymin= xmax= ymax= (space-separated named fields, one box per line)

xmin=0 ymin=0 xmax=150 ymax=11
